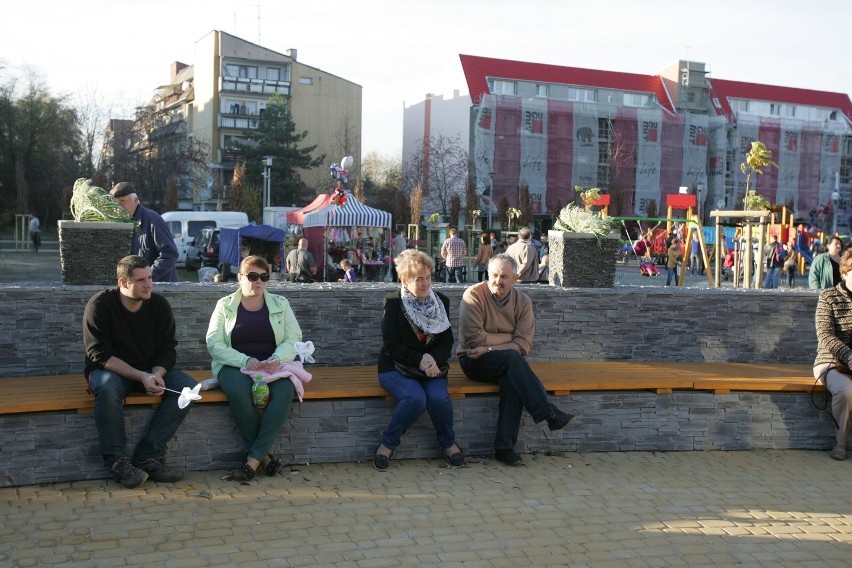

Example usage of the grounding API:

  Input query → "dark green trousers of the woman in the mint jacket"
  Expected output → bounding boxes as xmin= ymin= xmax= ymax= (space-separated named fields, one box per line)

xmin=219 ymin=365 xmax=296 ymax=461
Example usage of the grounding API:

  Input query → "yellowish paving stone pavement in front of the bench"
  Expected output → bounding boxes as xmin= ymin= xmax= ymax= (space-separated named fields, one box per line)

xmin=0 ymin=450 xmax=852 ymax=568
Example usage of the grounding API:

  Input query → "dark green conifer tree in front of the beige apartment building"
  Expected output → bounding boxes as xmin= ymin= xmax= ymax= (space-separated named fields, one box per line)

xmin=236 ymin=94 xmax=325 ymax=205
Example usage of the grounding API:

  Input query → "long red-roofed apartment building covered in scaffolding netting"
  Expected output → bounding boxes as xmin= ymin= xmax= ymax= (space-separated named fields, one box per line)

xmin=460 ymin=55 xmax=852 ymax=224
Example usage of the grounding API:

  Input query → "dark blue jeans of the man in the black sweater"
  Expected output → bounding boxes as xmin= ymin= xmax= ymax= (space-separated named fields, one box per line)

xmin=89 ymin=369 xmax=198 ymax=468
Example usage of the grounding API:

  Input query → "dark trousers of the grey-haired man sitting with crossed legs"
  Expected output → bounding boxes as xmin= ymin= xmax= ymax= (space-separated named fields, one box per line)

xmin=459 ymin=349 xmax=553 ymax=450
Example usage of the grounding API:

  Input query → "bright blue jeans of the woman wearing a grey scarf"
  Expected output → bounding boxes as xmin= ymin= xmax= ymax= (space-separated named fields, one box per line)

xmin=379 ymin=371 xmax=456 ymax=450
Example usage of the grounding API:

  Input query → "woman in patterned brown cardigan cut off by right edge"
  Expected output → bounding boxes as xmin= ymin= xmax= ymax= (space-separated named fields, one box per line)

xmin=814 ymin=250 xmax=852 ymax=461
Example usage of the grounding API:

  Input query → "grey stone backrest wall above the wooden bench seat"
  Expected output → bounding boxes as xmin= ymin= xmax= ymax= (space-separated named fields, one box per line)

xmin=0 ymin=283 xmax=818 ymax=380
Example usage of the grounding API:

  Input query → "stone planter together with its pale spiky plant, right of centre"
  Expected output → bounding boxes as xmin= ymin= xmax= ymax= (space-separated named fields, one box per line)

xmin=547 ymin=204 xmax=620 ymax=288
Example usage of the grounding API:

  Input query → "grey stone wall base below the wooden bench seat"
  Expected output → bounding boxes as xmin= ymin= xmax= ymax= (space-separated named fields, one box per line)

xmin=0 ymin=391 xmax=834 ymax=486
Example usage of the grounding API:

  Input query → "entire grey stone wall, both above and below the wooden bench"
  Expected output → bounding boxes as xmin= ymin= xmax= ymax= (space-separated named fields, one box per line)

xmin=0 ymin=283 xmax=833 ymax=486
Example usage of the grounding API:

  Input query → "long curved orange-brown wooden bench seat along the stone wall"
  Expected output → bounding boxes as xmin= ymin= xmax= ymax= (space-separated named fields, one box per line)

xmin=0 ymin=361 xmax=825 ymax=414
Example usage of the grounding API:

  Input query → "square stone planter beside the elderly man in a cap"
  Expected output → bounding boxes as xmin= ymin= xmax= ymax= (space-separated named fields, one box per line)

xmin=59 ymin=221 xmax=134 ymax=286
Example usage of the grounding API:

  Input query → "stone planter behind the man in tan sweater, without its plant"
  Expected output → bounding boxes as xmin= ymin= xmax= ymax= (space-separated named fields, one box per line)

xmin=547 ymin=231 xmax=620 ymax=288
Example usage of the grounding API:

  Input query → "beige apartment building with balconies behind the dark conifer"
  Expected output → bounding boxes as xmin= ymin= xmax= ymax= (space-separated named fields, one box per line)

xmin=103 ymin=30 xmax=362 ymax=209
